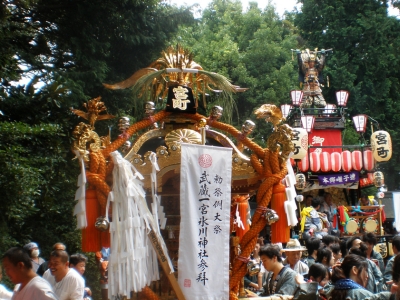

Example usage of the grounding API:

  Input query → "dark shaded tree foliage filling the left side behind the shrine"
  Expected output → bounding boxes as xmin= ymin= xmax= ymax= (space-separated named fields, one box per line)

xmin=0 ymin=0 xmax=193 ymax=299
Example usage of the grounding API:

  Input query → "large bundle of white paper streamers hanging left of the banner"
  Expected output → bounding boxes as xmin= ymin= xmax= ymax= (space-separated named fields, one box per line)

xmin=108 ymin=151 xmax=172 ymax=299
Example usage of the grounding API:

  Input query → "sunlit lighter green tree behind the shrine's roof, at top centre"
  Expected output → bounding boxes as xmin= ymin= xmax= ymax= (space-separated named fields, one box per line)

xmin=175 ymin=0 xmax=297 ymax=138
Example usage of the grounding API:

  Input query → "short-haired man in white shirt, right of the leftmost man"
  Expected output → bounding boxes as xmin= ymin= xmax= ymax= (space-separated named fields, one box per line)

xmin=43 ymin=250 xmax=85 ymax=300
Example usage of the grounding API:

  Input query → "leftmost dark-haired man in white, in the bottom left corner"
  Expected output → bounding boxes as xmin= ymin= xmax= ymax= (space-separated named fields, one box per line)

xmin=3 ymin=247 xmax=58 ymax=300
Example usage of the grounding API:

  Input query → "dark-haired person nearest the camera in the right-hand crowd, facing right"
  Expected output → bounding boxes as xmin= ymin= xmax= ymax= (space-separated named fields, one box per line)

xmin=329 ymin=254 xmax=390 ymax=300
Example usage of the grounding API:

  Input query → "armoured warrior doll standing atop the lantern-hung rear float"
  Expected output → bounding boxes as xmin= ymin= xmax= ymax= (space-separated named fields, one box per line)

xmin=296 ymin=48 xmax=331 ymax=108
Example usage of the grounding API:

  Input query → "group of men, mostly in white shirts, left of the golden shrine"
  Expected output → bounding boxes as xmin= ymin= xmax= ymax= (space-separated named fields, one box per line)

xmin=0 ymin=242 xmax=91 ymax=300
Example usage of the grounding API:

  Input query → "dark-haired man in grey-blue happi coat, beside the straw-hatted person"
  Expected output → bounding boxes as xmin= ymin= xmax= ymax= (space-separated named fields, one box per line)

xmin=260 ymin=245 xmax=297 ymax=296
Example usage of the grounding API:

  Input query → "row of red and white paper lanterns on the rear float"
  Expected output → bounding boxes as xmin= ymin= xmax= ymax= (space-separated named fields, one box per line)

xmin=293 ymin=150 xmax=375 ymax=172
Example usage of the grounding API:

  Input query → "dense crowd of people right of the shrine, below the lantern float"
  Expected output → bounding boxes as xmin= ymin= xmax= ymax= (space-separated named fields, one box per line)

xmin=245 ymin=233 xmax=400 ymax=300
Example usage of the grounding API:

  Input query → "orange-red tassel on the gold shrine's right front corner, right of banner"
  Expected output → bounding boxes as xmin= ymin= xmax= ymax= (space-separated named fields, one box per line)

xmin=271 ymin=183 xmax=290 ymax=243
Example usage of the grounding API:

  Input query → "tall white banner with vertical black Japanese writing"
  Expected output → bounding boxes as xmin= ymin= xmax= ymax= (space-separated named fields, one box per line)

xmin=178 ymin=143 xmax=232 ymax=300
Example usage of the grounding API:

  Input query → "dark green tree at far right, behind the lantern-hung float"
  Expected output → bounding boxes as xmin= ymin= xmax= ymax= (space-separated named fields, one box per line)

xmin=295 ymin=0 xmax=400 ymax=189
